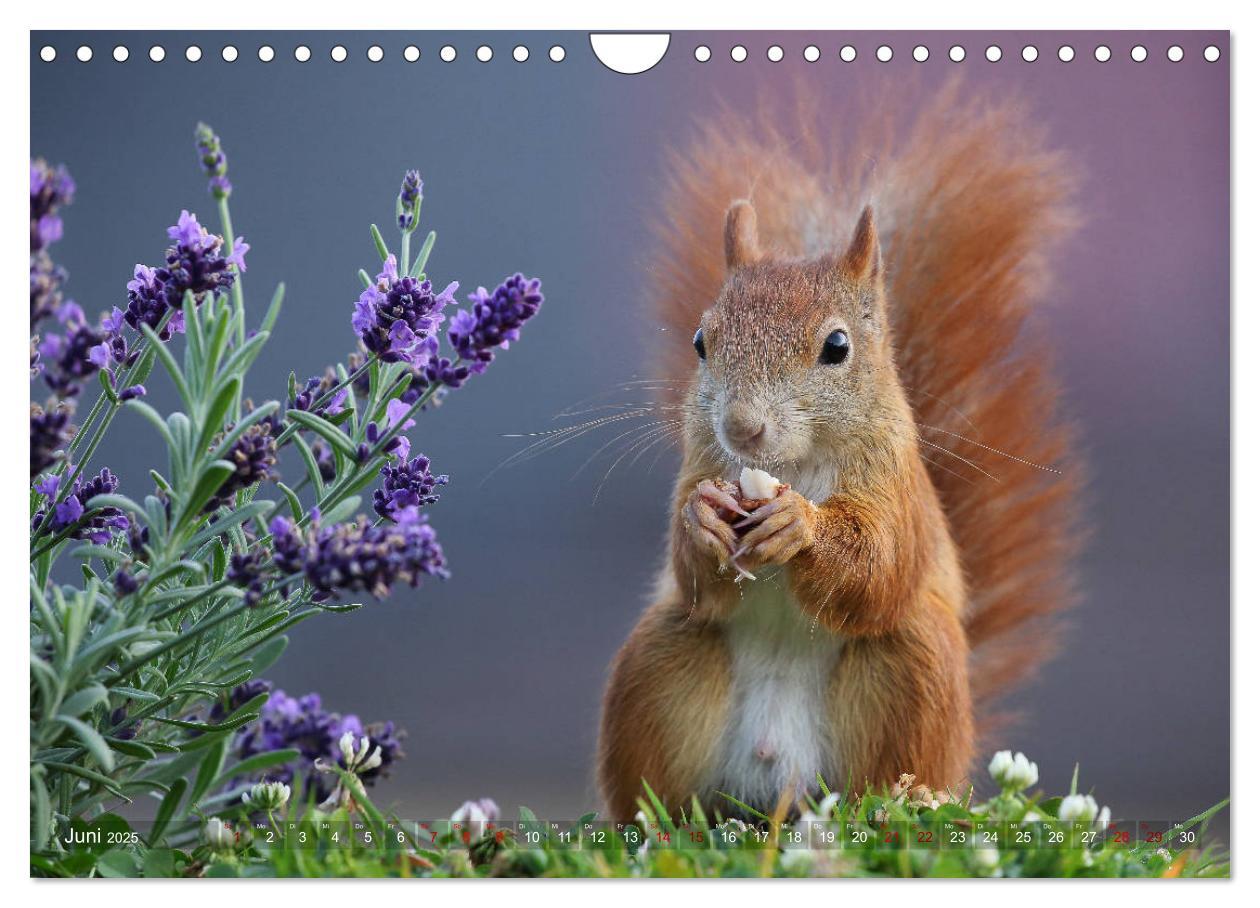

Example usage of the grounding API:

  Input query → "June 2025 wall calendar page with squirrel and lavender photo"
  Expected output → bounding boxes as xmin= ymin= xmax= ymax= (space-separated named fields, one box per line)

xmin=29 ymin=21 xmax=1232 ymax=879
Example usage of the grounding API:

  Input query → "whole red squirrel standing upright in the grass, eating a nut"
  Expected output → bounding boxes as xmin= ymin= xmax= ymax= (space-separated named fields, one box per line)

xmin=597 ymin=86 xmax=1081 ymax=822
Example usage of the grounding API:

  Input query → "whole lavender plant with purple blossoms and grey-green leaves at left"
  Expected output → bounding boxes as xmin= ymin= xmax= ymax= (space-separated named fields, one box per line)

xmin=30 ymin=125 xmax=543 ymax=874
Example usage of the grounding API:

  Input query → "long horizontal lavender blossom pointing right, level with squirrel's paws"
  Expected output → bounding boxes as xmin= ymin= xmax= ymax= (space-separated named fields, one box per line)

xmin=270 ymin=508 xmax=450 ymax=602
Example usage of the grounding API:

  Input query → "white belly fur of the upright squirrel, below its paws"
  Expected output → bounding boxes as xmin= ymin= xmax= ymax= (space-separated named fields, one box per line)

xmin=711 ymin=568 xmax=843 ymax=810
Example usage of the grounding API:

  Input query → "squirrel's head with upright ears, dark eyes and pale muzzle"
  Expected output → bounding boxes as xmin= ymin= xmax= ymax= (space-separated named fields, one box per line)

xmin=694 ymin=201 xmax=903 ymax=467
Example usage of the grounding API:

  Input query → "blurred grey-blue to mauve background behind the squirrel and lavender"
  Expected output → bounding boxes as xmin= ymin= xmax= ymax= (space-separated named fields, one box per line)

xmin=32 ymin=31 xmax=1230 ymax=831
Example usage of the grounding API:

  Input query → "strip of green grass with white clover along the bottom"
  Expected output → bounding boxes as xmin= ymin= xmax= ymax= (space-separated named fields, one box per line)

xmin=32 ymin=780 xmax=1230 ymax=878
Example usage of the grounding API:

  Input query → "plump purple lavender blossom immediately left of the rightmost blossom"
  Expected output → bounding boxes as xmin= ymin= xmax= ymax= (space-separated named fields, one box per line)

xmin=350 ymin=256 xmax=459 ymax=365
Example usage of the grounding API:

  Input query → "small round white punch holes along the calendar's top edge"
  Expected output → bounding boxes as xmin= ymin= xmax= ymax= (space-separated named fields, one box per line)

xmin=39 ymin=44 xmax=1221 ymax=63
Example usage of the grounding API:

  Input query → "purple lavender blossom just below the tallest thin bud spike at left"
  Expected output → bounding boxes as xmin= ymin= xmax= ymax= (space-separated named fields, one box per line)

xmin=123 ymin=210 xmax=249 ymax=340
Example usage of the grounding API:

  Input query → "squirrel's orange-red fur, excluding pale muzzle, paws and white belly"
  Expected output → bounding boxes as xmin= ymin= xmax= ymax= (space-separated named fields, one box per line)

xmin=600 ymin=86 xmax=1080 ymax=819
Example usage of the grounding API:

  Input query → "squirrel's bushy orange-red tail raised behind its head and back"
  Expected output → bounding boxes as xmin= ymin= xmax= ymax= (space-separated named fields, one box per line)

xmin=650 ymin=83 xmax=1081 ymax=732
